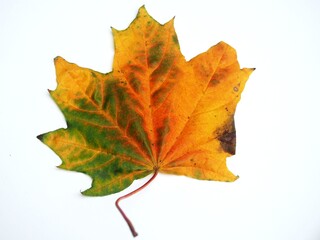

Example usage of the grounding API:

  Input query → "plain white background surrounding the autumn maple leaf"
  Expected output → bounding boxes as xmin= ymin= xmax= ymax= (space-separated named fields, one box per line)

xmin=0 ymin=0 xmax=320 ymax=240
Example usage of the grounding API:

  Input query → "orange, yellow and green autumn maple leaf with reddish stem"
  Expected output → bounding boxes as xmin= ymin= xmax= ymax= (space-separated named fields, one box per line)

xmin=38 ymin=7 xmax=254 ymax=235
